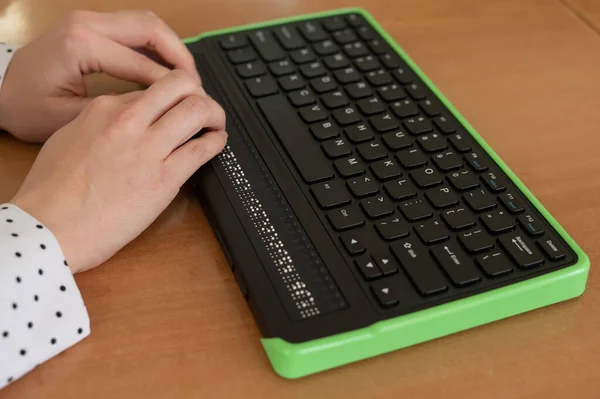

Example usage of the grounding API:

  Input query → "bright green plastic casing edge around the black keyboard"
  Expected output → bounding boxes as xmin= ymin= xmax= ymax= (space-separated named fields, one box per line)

xmin=184 ymin=8 xmax=590 ymax=378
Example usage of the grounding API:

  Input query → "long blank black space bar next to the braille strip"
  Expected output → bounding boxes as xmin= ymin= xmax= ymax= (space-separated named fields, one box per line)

xmin=258 ymin=95 xmax=333 ymax=183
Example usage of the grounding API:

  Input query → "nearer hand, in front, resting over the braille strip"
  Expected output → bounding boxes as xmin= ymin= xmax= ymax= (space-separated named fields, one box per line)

xmin=11 ymin=70 xmax=227 ymax=273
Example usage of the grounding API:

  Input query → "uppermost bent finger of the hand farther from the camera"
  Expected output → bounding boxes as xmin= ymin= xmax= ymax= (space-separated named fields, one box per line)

xmin=73 ymin=11 xmax=201 ymax=83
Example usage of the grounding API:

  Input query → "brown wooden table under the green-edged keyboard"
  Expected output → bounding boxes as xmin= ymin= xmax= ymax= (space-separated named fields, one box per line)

xmin=0 ymin=0 xmax=600 ymax=399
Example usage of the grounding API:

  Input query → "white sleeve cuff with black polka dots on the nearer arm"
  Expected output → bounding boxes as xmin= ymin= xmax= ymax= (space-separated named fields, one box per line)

xmin=0 ymin=204 xmax=90 ymax=389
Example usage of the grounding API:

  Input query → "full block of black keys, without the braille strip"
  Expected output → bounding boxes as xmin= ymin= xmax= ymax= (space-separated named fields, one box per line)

xmin=207 ymin=14 xmax=575 ymax=315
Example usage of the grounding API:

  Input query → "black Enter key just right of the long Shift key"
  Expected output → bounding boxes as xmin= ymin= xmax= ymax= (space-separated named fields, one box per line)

xmin=431 ymin=243 xmax=481 ymax=287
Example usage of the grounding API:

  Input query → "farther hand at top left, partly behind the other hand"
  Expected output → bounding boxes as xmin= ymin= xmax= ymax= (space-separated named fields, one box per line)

xmin=0 ymin=11 xmax=200 ymax=142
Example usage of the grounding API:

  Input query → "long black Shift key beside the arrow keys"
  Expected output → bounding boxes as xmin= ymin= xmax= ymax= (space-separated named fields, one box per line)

xmin=391 ymin=237 xmax=448 ymax=295
